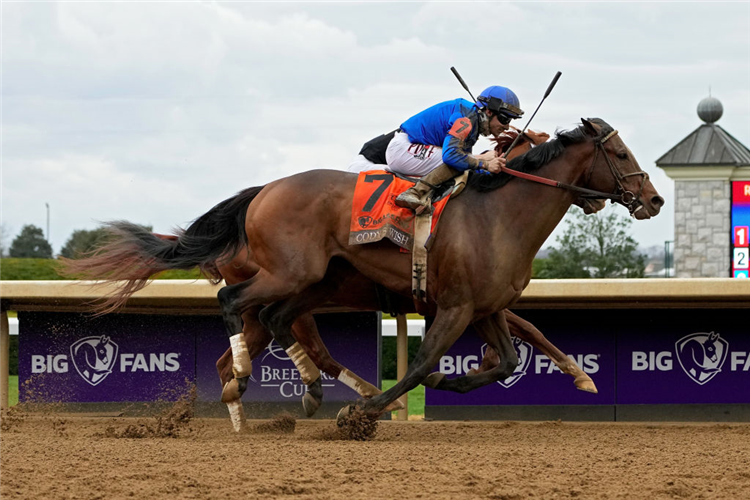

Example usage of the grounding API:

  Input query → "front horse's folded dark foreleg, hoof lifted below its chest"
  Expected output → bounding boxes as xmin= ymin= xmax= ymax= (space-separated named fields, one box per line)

xmin=423 ymin=311 xmax=518 ymax=393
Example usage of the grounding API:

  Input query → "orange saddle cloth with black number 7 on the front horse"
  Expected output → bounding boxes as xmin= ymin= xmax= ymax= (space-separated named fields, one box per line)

xmin=349 ymin=170 xmax=451 ymax=251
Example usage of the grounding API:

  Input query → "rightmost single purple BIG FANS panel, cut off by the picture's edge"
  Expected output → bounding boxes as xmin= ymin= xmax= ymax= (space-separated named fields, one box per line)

xmin=617 ymin=309 xmax=750 ymax=404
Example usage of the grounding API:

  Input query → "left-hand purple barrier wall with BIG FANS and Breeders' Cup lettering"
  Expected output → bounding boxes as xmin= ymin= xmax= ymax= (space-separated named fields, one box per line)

xmin=19 ymin=312 xmax=380 ymax=403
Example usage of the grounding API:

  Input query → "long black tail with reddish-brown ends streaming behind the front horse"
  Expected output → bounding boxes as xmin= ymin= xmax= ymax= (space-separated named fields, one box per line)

xmin=60 ymin=186 xmax=263 ymax=314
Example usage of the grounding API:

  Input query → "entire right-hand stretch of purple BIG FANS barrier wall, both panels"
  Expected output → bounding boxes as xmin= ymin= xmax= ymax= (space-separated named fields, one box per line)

xmin=425 ymin=309 xmax=750 ymax=416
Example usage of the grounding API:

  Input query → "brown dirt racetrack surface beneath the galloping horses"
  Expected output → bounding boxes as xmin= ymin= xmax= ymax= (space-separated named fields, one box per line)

xmin=0 ymin=413 xmax=750 ymax=499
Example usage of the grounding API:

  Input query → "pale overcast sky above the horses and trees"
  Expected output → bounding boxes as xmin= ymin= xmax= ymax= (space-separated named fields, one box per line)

xmin=0 ymin=1 xmax=750 ymax=253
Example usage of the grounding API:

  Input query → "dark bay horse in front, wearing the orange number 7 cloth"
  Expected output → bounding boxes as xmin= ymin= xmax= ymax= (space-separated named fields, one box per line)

xmin=64 ymin=119 xmax=664 ymax=422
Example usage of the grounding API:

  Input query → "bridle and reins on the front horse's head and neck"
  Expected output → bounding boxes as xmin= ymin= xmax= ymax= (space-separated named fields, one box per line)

xmin=500 ymin=130 xmax=648 ymax=215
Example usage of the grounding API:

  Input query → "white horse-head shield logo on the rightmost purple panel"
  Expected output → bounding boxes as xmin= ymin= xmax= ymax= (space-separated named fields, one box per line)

xmin=675 ymin=332 xmax=729 ymax=385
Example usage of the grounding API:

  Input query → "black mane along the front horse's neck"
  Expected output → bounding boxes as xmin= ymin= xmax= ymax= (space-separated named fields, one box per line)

xmin=467 ymin=118 xmax=614 ymax=193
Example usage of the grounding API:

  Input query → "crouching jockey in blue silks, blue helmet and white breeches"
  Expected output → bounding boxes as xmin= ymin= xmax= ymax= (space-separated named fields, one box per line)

xmin=349 ymin=85 xmax=523 ymax=210
